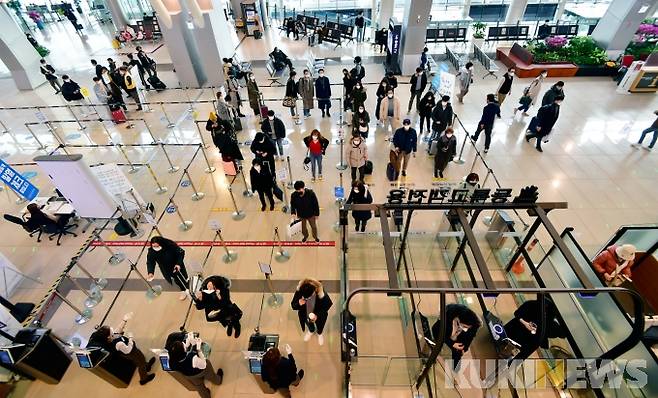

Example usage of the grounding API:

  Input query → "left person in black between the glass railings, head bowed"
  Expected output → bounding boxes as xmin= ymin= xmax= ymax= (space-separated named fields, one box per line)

xmin=432 ymin=304 xmax=482 ymax=370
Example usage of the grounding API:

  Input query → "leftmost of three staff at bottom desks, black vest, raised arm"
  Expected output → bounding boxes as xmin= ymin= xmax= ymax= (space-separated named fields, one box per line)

xmin=89 ymin=313 xmax=155 ymax=385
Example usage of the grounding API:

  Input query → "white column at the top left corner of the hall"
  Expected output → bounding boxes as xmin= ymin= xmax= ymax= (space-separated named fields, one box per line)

xmin=0 ymin=3 xmax=46 ymax=90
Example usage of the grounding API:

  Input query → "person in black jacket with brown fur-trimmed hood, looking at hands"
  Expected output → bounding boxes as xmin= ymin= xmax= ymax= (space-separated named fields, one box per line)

xmin=290 ymin=278 xmax=333 ymax=345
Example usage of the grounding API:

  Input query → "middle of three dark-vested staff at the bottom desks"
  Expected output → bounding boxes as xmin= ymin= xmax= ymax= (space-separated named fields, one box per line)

xmin=169 ymin=333 xmax=224 ymax=398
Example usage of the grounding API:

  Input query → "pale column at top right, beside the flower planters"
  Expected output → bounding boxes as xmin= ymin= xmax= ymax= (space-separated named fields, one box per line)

xmin=592 ymin=0 xmax=658 ymax=59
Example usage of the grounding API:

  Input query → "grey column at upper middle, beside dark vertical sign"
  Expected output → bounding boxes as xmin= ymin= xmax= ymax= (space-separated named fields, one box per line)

xmin=399 ymin=0 xmax=432 ymax=75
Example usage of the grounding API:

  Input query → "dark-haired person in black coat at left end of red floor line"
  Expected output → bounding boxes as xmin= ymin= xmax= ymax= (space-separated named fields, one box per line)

xmin=146 ymin=236 xmax=189 ymax=300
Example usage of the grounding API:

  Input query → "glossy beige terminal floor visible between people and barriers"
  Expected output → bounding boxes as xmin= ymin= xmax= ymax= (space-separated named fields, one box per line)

xmin=0 ymin=15 xmax=658 ymax=397
